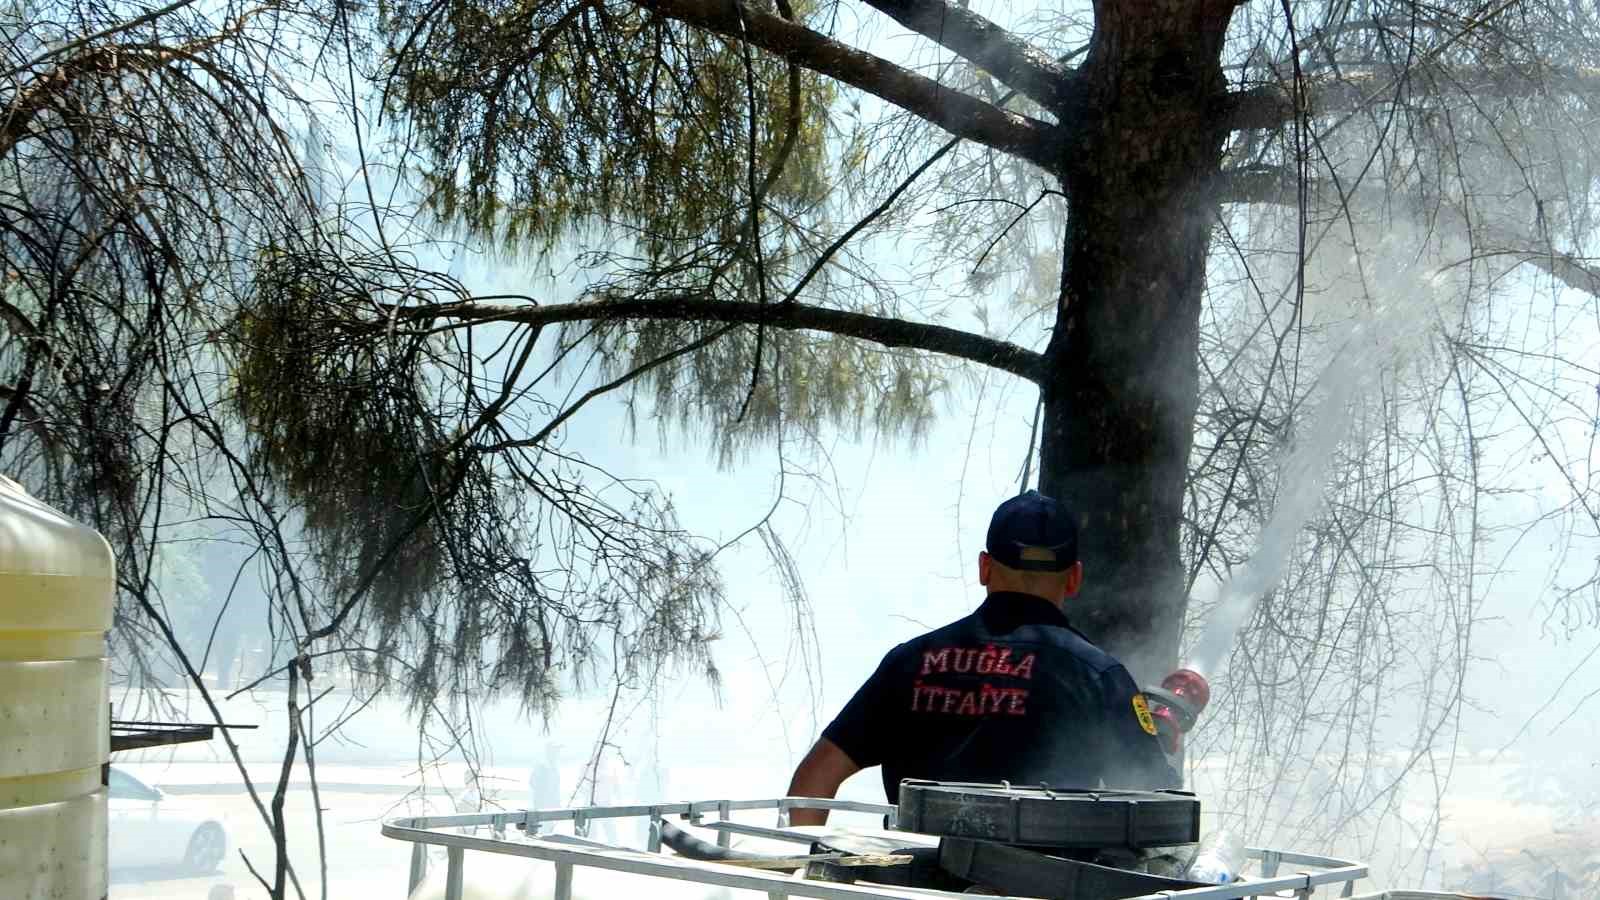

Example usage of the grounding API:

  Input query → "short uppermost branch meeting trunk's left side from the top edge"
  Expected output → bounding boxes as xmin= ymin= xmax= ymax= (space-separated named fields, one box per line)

xmin=867 ymin=0 xmax=1074 ymax=112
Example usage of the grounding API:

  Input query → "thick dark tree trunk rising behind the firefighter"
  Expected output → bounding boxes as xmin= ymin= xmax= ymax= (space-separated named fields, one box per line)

xmin=1040 ymin=0 xmax=1232 ymax=684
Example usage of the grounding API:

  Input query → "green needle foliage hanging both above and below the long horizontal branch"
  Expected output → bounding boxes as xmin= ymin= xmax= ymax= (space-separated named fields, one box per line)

xmin=379 ymin=0 xmax=950 ymax=454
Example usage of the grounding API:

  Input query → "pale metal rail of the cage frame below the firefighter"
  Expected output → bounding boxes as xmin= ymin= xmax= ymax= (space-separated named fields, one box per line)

xmin=382 ymin=798 xmax=1369 ymax=900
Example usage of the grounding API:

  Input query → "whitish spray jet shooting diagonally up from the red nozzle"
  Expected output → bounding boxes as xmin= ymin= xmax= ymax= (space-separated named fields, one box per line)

xmin=1189 ymin=239 xmax=1448 ymax=677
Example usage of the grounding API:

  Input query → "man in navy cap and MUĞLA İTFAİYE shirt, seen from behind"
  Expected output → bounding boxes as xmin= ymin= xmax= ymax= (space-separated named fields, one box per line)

xmin=789 ymin=490 xmax=1179 ymax=825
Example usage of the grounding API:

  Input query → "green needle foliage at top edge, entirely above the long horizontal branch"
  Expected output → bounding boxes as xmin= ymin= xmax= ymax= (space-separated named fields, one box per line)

xmin=379 ymin=0 xmax=834 ymax=254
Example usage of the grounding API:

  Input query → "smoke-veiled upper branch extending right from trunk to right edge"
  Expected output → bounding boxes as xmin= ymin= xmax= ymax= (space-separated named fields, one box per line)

xmin=1222 ymin=64 xmax=1600 ymax=131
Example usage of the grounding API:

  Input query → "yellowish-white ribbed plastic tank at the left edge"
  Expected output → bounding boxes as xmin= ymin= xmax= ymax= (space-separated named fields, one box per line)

xmin=0 ymin=476 xmax=115 ymax=900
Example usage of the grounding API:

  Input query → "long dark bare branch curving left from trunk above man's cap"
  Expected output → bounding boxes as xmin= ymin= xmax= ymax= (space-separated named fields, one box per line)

xmin=386 ymin=295 xmax=1043 ymax=383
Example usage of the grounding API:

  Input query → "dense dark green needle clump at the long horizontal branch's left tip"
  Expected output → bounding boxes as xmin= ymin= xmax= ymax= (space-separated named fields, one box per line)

xmin=232 ymin=250 xmax=451 ymax=628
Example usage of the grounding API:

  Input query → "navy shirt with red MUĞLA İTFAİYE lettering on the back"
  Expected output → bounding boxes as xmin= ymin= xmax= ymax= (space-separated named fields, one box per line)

xmin=822 ymin=593 xmax=1181 ymax=802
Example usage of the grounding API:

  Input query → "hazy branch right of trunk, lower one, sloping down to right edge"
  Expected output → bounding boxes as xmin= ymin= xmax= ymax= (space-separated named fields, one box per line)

xmin=1214 ymin=167 xmax=1600 ymax=296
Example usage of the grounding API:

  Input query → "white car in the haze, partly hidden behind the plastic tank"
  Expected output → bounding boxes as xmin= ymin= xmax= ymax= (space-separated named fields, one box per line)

xmin=107 ymin=765 xmax=227 ymax=874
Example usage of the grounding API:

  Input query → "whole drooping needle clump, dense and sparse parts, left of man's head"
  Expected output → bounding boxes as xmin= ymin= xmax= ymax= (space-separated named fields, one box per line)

xmin=229 ymin=250 xmax=723 ymax=714
